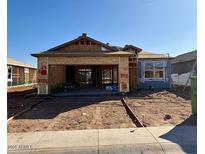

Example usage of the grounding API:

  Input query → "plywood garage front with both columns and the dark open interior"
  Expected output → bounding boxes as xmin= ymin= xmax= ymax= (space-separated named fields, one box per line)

xmin=38 ymin=56 xmax=129 ymax=95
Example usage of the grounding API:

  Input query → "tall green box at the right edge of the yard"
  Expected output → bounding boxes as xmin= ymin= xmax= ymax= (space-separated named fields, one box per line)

xmin=191 ymin=76 xmax=197 ymax=114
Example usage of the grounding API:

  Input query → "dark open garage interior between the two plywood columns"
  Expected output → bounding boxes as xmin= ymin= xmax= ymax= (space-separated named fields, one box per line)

xmin=49 ymin=65 xmax=118 ymax=93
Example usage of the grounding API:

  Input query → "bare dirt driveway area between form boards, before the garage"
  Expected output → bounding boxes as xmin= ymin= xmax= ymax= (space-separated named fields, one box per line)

xmin=8 ymin=96 xmax=135 ymax=133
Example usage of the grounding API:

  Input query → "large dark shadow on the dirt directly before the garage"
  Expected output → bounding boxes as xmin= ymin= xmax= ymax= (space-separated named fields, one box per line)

xmin=15 ymin=96 xmax=122 ymax=119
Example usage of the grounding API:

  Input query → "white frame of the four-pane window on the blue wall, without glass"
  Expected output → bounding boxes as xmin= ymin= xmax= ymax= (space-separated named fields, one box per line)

xmin=144 ymin=61 xmax=166 ymax=81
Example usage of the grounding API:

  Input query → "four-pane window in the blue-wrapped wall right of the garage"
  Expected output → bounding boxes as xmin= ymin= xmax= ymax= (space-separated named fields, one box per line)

xmin=145 ymin=61 xmax=165 ymax=79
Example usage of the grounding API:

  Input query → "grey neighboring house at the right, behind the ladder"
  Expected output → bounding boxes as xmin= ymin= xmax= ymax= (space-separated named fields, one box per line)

xmin=171 ymin=50 xmax=197 ymax=85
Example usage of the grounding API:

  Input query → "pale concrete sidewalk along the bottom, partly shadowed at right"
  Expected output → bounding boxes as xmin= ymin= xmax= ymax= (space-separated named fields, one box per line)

xmin=8 ymin=126 xmax=197 ymax=154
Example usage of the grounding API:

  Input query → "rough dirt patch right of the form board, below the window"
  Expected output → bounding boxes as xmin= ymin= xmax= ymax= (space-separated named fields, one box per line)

xmin=126 ymin=89 xmax=196 ymax=126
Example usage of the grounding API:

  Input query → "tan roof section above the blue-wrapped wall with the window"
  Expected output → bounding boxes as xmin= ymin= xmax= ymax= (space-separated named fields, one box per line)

xmin=138 ymin=51 xmax=172 ymax=59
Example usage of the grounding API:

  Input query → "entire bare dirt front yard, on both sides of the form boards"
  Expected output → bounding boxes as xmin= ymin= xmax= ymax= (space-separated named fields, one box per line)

xmin=8 ymin=89 xmax=197 ymax=133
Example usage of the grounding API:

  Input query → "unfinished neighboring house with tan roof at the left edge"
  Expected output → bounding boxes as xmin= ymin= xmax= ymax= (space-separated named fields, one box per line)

xmin=7 ymin=58 xmax=37 ymax=87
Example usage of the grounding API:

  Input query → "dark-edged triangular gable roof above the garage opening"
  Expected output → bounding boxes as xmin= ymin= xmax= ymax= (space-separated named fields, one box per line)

xmin=31 ymin=33 xmax=142 ymax=57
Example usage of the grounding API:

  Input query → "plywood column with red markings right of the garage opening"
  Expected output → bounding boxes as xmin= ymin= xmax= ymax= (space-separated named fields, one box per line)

xmin=118 ymin=57 xmax=129 ymax=92
